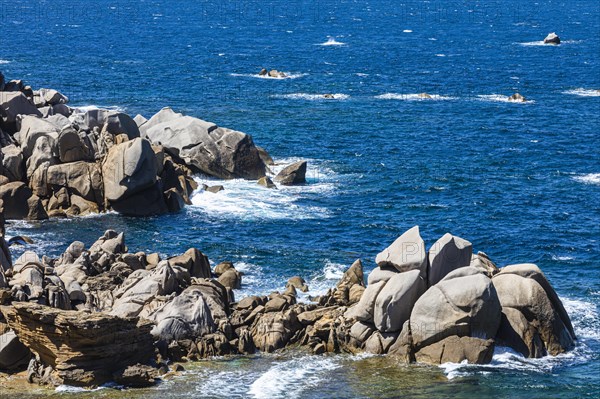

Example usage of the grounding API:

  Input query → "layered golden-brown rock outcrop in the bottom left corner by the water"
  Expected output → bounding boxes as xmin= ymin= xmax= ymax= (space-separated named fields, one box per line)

xmin=0 ymin=302 xmax=154 ymax=386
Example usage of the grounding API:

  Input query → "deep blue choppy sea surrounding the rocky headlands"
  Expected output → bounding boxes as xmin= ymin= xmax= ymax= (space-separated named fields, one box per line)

xmin=0 ymin=0 xmax=600 ymax=399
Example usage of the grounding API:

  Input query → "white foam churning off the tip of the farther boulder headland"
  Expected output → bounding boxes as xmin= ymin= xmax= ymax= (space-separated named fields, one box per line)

xmin=190 ymin=158 xmax=337 ymax=220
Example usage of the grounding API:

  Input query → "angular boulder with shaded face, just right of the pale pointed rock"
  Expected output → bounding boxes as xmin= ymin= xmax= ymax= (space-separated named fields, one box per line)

xmin=427 ymin=233 xmax=473 ymax=286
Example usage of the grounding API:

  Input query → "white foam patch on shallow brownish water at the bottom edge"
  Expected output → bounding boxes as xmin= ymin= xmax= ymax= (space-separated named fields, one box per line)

xmin=248 ymin=356 xmax=341 ymax=399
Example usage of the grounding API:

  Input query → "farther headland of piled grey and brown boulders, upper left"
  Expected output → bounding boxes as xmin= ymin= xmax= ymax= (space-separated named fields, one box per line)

xmin=0 ymin=72 xmax=304 ymax=220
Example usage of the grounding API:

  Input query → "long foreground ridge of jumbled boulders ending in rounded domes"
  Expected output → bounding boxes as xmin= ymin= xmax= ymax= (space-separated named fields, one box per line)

xmin=0 ymin=226 xmax=576 ymax=387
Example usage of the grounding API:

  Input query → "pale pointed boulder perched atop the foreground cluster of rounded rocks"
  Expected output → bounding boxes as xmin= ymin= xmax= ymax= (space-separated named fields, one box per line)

xmin=375 ymin=226 xmax=427 ymax=272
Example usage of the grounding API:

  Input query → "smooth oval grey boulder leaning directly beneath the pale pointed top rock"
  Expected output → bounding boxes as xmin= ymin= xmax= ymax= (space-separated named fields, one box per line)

xmin=373 ymin=270 xmax=427 ymax=332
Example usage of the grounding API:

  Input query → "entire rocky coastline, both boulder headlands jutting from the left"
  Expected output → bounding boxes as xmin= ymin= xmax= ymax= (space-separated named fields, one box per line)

xmin=0 ymin=73 xmax=576 ymax=387
